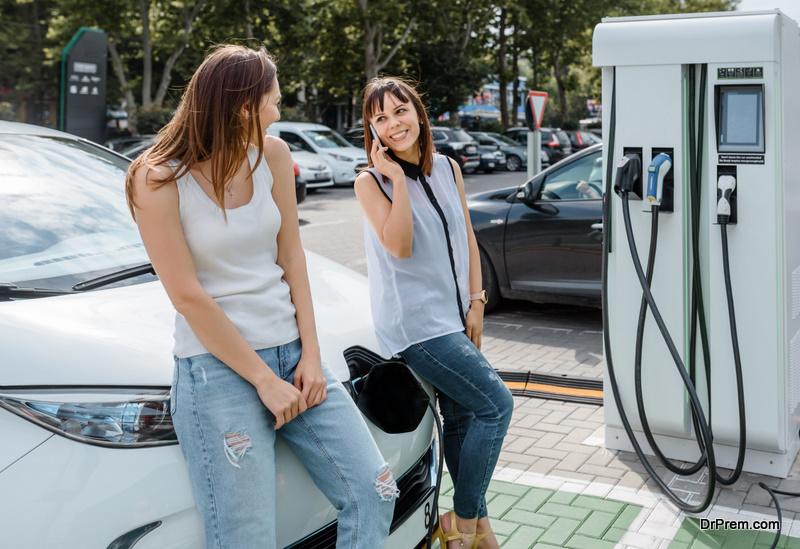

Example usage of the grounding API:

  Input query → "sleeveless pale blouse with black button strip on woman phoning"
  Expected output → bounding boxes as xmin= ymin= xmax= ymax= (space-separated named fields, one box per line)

xmin=364 ymin=154 xmax=469 ymax=354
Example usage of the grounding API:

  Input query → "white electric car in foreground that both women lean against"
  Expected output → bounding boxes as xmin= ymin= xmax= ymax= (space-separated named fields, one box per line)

xmin=0 ymin=122 xmax=436 ymax=549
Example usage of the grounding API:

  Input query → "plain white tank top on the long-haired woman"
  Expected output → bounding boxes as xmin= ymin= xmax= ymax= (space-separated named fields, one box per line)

xmin=173 ymin=147 xmax=299 ymax=358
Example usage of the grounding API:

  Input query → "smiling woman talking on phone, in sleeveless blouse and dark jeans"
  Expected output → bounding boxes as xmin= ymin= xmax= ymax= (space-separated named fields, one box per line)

xmin=355 ymin=78 xmax=514 ymax=549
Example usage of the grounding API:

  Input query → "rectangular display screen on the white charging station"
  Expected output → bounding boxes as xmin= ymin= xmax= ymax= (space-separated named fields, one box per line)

xmin=718 ymin=85 xmax=764 ymax=153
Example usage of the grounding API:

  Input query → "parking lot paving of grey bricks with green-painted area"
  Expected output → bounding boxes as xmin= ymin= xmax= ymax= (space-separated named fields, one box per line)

xmin=300 ymin=179 xmax=800 ymax=549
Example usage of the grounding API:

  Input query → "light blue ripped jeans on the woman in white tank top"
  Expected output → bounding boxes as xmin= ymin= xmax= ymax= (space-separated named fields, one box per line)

xmin=171 ymin=339 xmax=397 ymax=549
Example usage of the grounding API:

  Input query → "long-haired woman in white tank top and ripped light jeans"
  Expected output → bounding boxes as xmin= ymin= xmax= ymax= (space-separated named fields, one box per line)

xmin=126 ymin=46 xmax=397 ymax=549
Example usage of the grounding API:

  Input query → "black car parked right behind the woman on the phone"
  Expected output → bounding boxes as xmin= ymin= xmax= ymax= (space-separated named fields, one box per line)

xmin=467 ymin=145 xmax=603 ymax=311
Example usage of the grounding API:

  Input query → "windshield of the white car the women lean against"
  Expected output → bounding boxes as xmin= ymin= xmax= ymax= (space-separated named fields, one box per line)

xmin=0 ymin=134 xmax=154 ymax=289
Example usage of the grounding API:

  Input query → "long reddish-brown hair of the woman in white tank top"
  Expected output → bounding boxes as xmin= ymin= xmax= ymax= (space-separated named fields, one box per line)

xmin=125 ymin=44 xmax=277 ymax=218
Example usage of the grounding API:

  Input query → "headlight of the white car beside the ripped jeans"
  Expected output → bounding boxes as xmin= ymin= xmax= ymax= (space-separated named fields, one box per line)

xmin=0 ymin=389 xmax=178 ymax=448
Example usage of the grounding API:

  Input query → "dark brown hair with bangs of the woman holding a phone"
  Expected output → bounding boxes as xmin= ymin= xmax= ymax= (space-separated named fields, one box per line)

xmin=362 ymin=76 xmax=433 ymax=175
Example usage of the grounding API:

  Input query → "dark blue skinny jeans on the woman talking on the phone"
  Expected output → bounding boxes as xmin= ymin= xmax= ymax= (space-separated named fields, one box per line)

xmin=400 ymin=332 xmax=514 ymax=518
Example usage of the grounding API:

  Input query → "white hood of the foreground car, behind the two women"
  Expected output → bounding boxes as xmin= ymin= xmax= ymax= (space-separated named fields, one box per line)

xmin=0 ymin=252 xmax=386 ymax=387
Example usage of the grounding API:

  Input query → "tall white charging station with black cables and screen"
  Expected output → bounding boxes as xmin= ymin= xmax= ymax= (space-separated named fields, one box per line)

xmin=593 ymin=10 xmax=800 ymax=491
